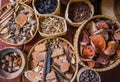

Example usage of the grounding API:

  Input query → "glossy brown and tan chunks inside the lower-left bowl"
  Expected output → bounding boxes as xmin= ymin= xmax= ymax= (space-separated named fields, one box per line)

xmin=0 ymin=52 xmax=22 ymax=73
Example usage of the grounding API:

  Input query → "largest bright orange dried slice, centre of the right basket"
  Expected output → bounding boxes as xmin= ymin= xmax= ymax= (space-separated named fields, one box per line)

xmin=90 ymin=35 xmax=106 ymax=52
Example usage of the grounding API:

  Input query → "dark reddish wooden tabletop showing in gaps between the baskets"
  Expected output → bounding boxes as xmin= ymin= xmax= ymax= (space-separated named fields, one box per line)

xmin=0 ymin=0 xmax=120 ymax=82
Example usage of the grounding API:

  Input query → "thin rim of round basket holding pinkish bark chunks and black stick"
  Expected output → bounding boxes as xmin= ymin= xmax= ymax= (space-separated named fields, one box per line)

xmin=27 ymin=37 xmax=78 ymax=82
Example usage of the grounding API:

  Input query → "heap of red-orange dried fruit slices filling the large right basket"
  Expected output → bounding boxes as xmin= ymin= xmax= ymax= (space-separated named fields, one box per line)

xmin=79 ymin=18 xmax=120 ymax=68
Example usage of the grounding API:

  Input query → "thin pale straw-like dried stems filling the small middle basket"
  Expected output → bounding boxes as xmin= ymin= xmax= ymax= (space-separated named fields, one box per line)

xmin=40 ymin=16 xmax=66 ymax=34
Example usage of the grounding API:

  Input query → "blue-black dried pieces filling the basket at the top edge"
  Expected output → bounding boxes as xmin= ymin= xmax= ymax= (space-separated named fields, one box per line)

xmin=35 ymin=0 xmax=58 ymax=14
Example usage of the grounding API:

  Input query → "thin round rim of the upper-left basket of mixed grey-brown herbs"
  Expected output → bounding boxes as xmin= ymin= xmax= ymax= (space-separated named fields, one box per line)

xmin=0 ymin=2 xmax=38 ymax=46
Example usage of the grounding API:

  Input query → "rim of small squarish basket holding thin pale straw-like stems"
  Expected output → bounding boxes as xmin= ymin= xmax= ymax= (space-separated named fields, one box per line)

xmin=38 ymin=15 xmax=67 ymax=37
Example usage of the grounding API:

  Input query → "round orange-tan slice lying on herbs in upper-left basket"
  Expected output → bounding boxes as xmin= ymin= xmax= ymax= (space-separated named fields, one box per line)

xmin=15 ymin=14 xmax=27 ymax=27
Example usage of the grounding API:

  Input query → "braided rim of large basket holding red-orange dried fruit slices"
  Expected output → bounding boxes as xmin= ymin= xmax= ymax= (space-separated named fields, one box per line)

xmin=74 ymin=15 xmax=120 ymax=72
